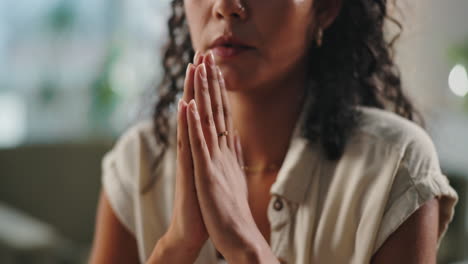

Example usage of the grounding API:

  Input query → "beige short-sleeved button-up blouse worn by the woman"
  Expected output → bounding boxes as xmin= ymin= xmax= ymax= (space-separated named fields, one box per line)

xmin=102 ymin=92 xmax=458 ymax=264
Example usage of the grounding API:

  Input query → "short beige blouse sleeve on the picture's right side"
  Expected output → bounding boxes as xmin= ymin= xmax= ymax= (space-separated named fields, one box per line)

xmin=373 ymin=127 xmax=458 ymax=254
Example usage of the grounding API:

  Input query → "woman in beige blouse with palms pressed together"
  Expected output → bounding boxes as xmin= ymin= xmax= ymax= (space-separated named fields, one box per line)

xmin=87 ymin=0 xmax=458 ymax=263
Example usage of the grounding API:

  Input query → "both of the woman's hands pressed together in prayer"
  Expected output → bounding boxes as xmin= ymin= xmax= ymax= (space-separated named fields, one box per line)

xmin=151 ymin=51 xmax=276 ymax=263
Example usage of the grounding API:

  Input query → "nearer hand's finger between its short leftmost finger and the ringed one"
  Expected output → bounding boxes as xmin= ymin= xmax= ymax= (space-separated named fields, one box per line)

xmin=195 ymin=63 xmax=219 ymax=155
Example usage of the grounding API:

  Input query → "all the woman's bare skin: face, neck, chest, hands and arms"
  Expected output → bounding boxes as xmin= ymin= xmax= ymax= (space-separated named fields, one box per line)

xmin=91 ymin=0 xmax=438 ymax=263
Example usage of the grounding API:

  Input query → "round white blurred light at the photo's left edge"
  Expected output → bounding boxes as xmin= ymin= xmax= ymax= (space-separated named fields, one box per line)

xmin=0 ymin=94 xmax=26 ymax=147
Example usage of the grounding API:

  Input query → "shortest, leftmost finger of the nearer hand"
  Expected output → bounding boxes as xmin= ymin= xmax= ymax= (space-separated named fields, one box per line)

xmin=187 ymin=100 xmax=210 ymax=171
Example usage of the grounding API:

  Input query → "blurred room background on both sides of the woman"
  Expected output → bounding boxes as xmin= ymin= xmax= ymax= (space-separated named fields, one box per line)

xmin=0 ymin=0 xmax=468 ymax=263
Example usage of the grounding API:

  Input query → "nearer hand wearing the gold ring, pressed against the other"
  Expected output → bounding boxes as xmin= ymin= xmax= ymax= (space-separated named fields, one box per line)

xmin=187 ymin=53 xmax=275 ymax=263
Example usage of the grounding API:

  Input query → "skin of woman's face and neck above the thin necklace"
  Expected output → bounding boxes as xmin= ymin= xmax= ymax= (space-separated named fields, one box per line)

xmin=185 ymin=0 xmax=338 ymax=176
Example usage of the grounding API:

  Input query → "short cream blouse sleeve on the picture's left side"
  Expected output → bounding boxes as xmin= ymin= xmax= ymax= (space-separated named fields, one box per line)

xmin=101 ymin=121 xmax=152 ymax=234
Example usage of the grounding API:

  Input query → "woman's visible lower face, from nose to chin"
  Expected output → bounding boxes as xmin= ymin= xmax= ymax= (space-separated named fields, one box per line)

xmin=184 ymin=0 xmax=314 ymax=93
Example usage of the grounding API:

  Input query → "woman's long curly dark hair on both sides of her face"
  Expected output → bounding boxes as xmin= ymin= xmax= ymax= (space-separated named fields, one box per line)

xmin=141 ymin=0 xmax=424 ymax=194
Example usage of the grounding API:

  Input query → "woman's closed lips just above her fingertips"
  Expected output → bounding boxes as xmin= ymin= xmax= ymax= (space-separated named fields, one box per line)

xmin=210 ymin=35 xmax=253 ymax=58
